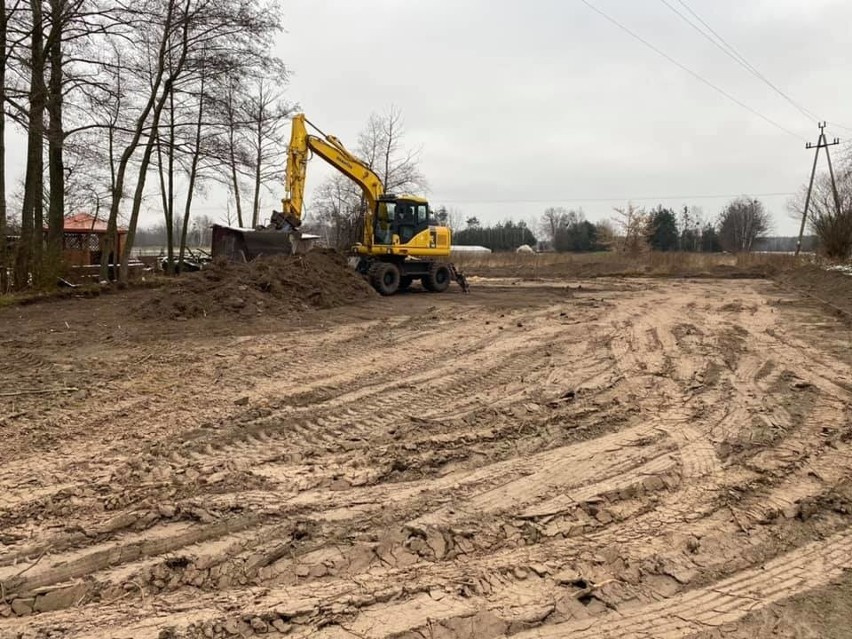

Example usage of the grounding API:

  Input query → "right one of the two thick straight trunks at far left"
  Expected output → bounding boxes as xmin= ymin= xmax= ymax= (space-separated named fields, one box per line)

xmin=45 ymin=0 xmax=65 ymax=280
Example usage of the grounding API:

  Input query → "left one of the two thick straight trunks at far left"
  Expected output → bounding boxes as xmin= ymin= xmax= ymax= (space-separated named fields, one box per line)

xmin=17 ymin=2 xmax=45 ymax=289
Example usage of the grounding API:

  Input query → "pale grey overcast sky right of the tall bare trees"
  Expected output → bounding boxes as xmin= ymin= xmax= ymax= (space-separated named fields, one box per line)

xmin=10 ymin=0 xmax=852 ymax=234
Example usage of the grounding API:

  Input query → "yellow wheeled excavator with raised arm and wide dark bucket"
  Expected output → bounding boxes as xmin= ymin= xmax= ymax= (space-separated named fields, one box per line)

xmin=213 ymin=113 xmax=469 ymax=295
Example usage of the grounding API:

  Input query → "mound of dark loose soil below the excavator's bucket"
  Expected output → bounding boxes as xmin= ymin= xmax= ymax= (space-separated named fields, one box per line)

xmin=138 ymin=250 xmax=376 ymax=319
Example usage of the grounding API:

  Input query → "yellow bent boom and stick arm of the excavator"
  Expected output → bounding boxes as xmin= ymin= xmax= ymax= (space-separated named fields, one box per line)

xmin=281 ymin=113 xmax=384 ymax=246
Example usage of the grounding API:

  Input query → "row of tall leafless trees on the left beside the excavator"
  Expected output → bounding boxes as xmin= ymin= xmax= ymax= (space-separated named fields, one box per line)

xmin=0 ymin=0 xmax=289 ymax=291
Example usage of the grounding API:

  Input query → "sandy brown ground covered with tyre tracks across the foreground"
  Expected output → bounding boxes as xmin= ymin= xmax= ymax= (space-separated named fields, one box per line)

xmin=0 ymin=279 xmax=852 ymax=639
